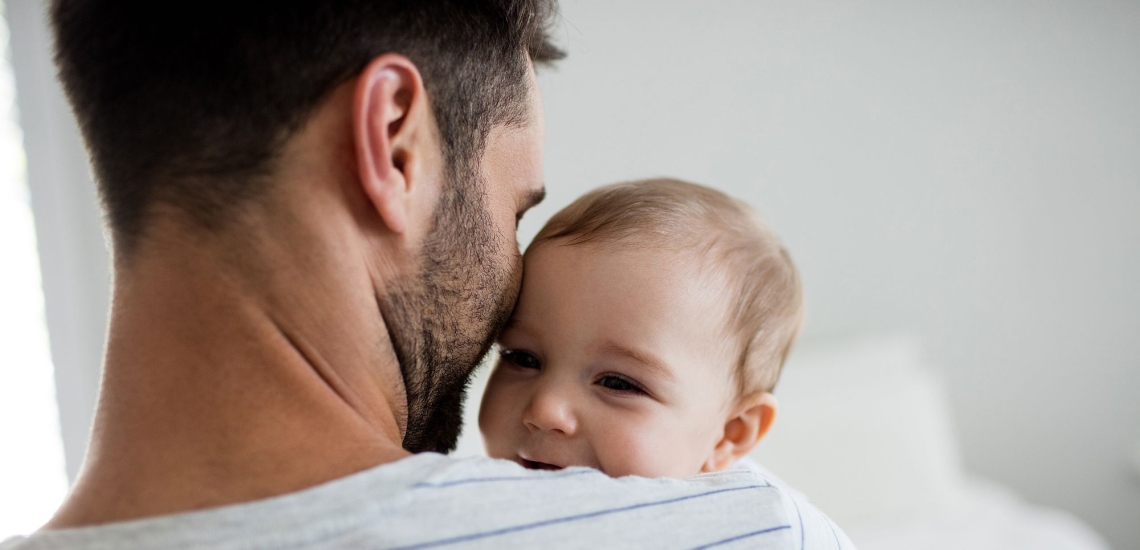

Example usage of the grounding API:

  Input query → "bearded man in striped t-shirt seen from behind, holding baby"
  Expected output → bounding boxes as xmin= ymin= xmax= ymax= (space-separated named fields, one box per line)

xmin=2 ymin=0 xmax=846 ymax=550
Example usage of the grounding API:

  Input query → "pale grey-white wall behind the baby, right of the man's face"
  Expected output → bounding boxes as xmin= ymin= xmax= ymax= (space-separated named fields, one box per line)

xmin=523 ymin=0 xmax=1140 ymax=549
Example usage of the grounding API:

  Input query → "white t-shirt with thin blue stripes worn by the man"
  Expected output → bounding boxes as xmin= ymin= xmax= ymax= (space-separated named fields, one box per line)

xmin=0 ymin=453 xmax=855 ymax=550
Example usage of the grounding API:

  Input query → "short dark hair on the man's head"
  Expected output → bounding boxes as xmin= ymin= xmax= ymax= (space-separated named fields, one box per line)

xmin=50 ymin=0 xmax=563 ymax=251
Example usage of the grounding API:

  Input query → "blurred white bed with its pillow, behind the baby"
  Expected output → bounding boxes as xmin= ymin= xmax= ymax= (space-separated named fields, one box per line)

xmin=752 ymin=338 xmax=1107 ymax=550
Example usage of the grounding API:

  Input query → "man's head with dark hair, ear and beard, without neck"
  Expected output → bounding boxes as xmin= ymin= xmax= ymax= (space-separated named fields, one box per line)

xmin=51 ymin=0 xmax=562 ymax=451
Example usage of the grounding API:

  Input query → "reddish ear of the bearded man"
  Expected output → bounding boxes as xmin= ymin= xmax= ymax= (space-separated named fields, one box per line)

xmin=352 ymin=54 xmax=432 ymax=233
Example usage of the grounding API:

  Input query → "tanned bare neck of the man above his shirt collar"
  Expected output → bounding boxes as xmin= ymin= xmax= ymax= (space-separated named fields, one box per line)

xmin=47 ymin=222 xmax=407 ymax=528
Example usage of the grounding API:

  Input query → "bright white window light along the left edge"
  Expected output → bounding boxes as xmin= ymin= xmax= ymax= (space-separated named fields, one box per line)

xmin=0 ymin=2 xmax=67 ymax=540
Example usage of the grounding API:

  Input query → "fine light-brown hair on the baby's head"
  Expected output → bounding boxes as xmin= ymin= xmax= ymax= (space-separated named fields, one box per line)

xmin=528 ymin=178 xmax=804 ymax=397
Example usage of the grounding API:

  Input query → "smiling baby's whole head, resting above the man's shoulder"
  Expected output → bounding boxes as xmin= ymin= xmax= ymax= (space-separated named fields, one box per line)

xmin=479 ymin=179 xmax=803 ymax=477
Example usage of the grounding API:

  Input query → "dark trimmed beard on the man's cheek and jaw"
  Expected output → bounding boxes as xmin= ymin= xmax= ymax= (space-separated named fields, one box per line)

xmin=378 ymin=171 xmax=521 ymax=453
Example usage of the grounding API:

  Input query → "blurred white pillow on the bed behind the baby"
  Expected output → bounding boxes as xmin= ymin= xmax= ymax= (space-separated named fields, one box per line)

xmin=752 ymin=338 xmax=961 ymax=526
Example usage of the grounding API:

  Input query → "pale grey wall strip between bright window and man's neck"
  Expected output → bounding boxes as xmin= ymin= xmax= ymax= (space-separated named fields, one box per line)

xmin=5 ymin=0 xmax=111 ymax=480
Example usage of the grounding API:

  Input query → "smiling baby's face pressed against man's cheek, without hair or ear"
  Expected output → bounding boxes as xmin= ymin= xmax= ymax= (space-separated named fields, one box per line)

xmin=479 ymin=242 xmax=736 ymax=477
